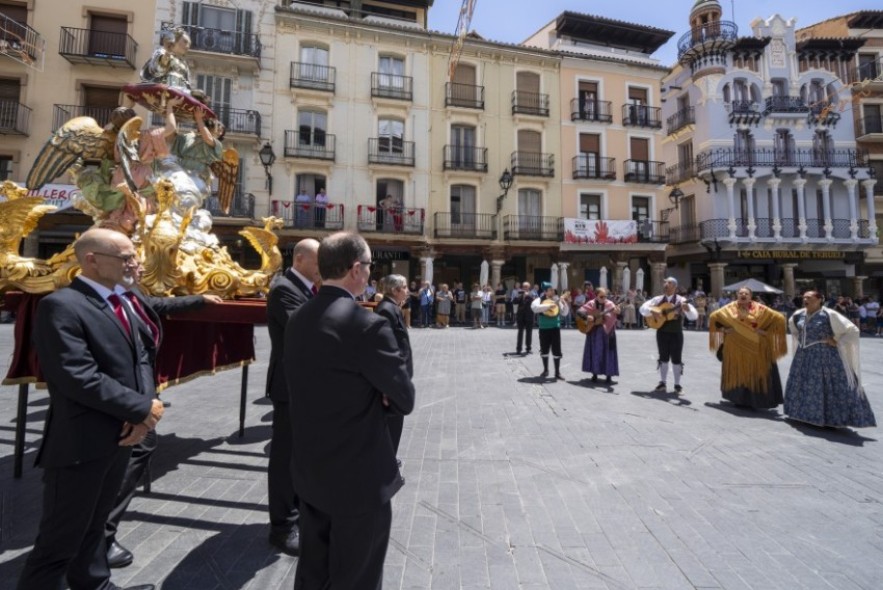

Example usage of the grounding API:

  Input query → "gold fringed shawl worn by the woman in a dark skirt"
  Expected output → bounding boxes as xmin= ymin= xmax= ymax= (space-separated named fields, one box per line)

xmin=708 ymin=301 xmax=788 ymax=393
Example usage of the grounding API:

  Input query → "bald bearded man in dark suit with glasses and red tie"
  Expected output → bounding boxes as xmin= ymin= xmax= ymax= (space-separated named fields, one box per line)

xmin=18 ymin=229 xmax=163 ymax=590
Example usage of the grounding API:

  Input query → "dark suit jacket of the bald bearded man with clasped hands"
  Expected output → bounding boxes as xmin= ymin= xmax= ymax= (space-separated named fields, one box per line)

xmin=33 ymin=279 xmax=159 ymax=467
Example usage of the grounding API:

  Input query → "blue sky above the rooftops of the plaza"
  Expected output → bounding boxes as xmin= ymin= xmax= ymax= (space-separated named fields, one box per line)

xmin=429 ymin=0 xmax=881 ymax=65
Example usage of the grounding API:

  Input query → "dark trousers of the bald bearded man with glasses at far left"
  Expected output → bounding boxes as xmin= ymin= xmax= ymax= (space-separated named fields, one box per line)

xmin=17 ymin=447 xmax=130 ymax=590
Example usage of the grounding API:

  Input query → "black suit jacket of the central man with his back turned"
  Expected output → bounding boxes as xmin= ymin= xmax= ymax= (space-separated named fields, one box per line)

xmin=285 ymin=285 xmax=414 ymax=515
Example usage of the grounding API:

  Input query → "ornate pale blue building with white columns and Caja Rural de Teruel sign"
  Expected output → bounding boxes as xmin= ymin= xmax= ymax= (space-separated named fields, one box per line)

xmin=663 ymin=0 xmax=877 ymax=296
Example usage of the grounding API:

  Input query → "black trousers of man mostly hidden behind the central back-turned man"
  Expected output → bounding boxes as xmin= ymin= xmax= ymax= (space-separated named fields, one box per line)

xmin=267 ymin=400 xmax=298 ymax=533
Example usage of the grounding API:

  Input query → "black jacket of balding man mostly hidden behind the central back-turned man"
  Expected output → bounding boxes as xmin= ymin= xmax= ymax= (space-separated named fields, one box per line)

xmin=266 ymin=268 xmax=313 ymax=402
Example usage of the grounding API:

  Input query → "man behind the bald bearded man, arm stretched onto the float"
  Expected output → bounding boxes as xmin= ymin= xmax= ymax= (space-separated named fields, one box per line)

xmin=104 ymin=264 xmax=222 ymax=568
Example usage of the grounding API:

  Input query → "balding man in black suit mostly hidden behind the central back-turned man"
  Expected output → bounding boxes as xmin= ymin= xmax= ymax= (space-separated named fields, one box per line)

xmin=267 ymin=238 xmax=319 ymax=555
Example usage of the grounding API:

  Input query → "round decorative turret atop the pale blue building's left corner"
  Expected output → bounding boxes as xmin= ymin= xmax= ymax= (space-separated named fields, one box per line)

xmin=678 ymin=0 xmax=739 ymax=72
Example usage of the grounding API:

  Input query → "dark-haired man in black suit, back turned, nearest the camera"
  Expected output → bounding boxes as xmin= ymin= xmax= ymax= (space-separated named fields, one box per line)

xmin=285 ymin=232 xmax=414 ymax=590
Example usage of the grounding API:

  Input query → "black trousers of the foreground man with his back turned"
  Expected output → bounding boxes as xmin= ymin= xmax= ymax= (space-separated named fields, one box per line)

xmin=294 ymin=499 xmax=392 ymax=590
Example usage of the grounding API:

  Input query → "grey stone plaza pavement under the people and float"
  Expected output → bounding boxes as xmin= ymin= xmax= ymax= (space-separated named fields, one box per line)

xmin=0 ymin=325 xmax=883 ymax=590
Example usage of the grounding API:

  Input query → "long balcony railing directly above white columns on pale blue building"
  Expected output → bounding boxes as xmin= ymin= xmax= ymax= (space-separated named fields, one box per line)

xmin=696 ymin=148 xmax=867 ymax=172
